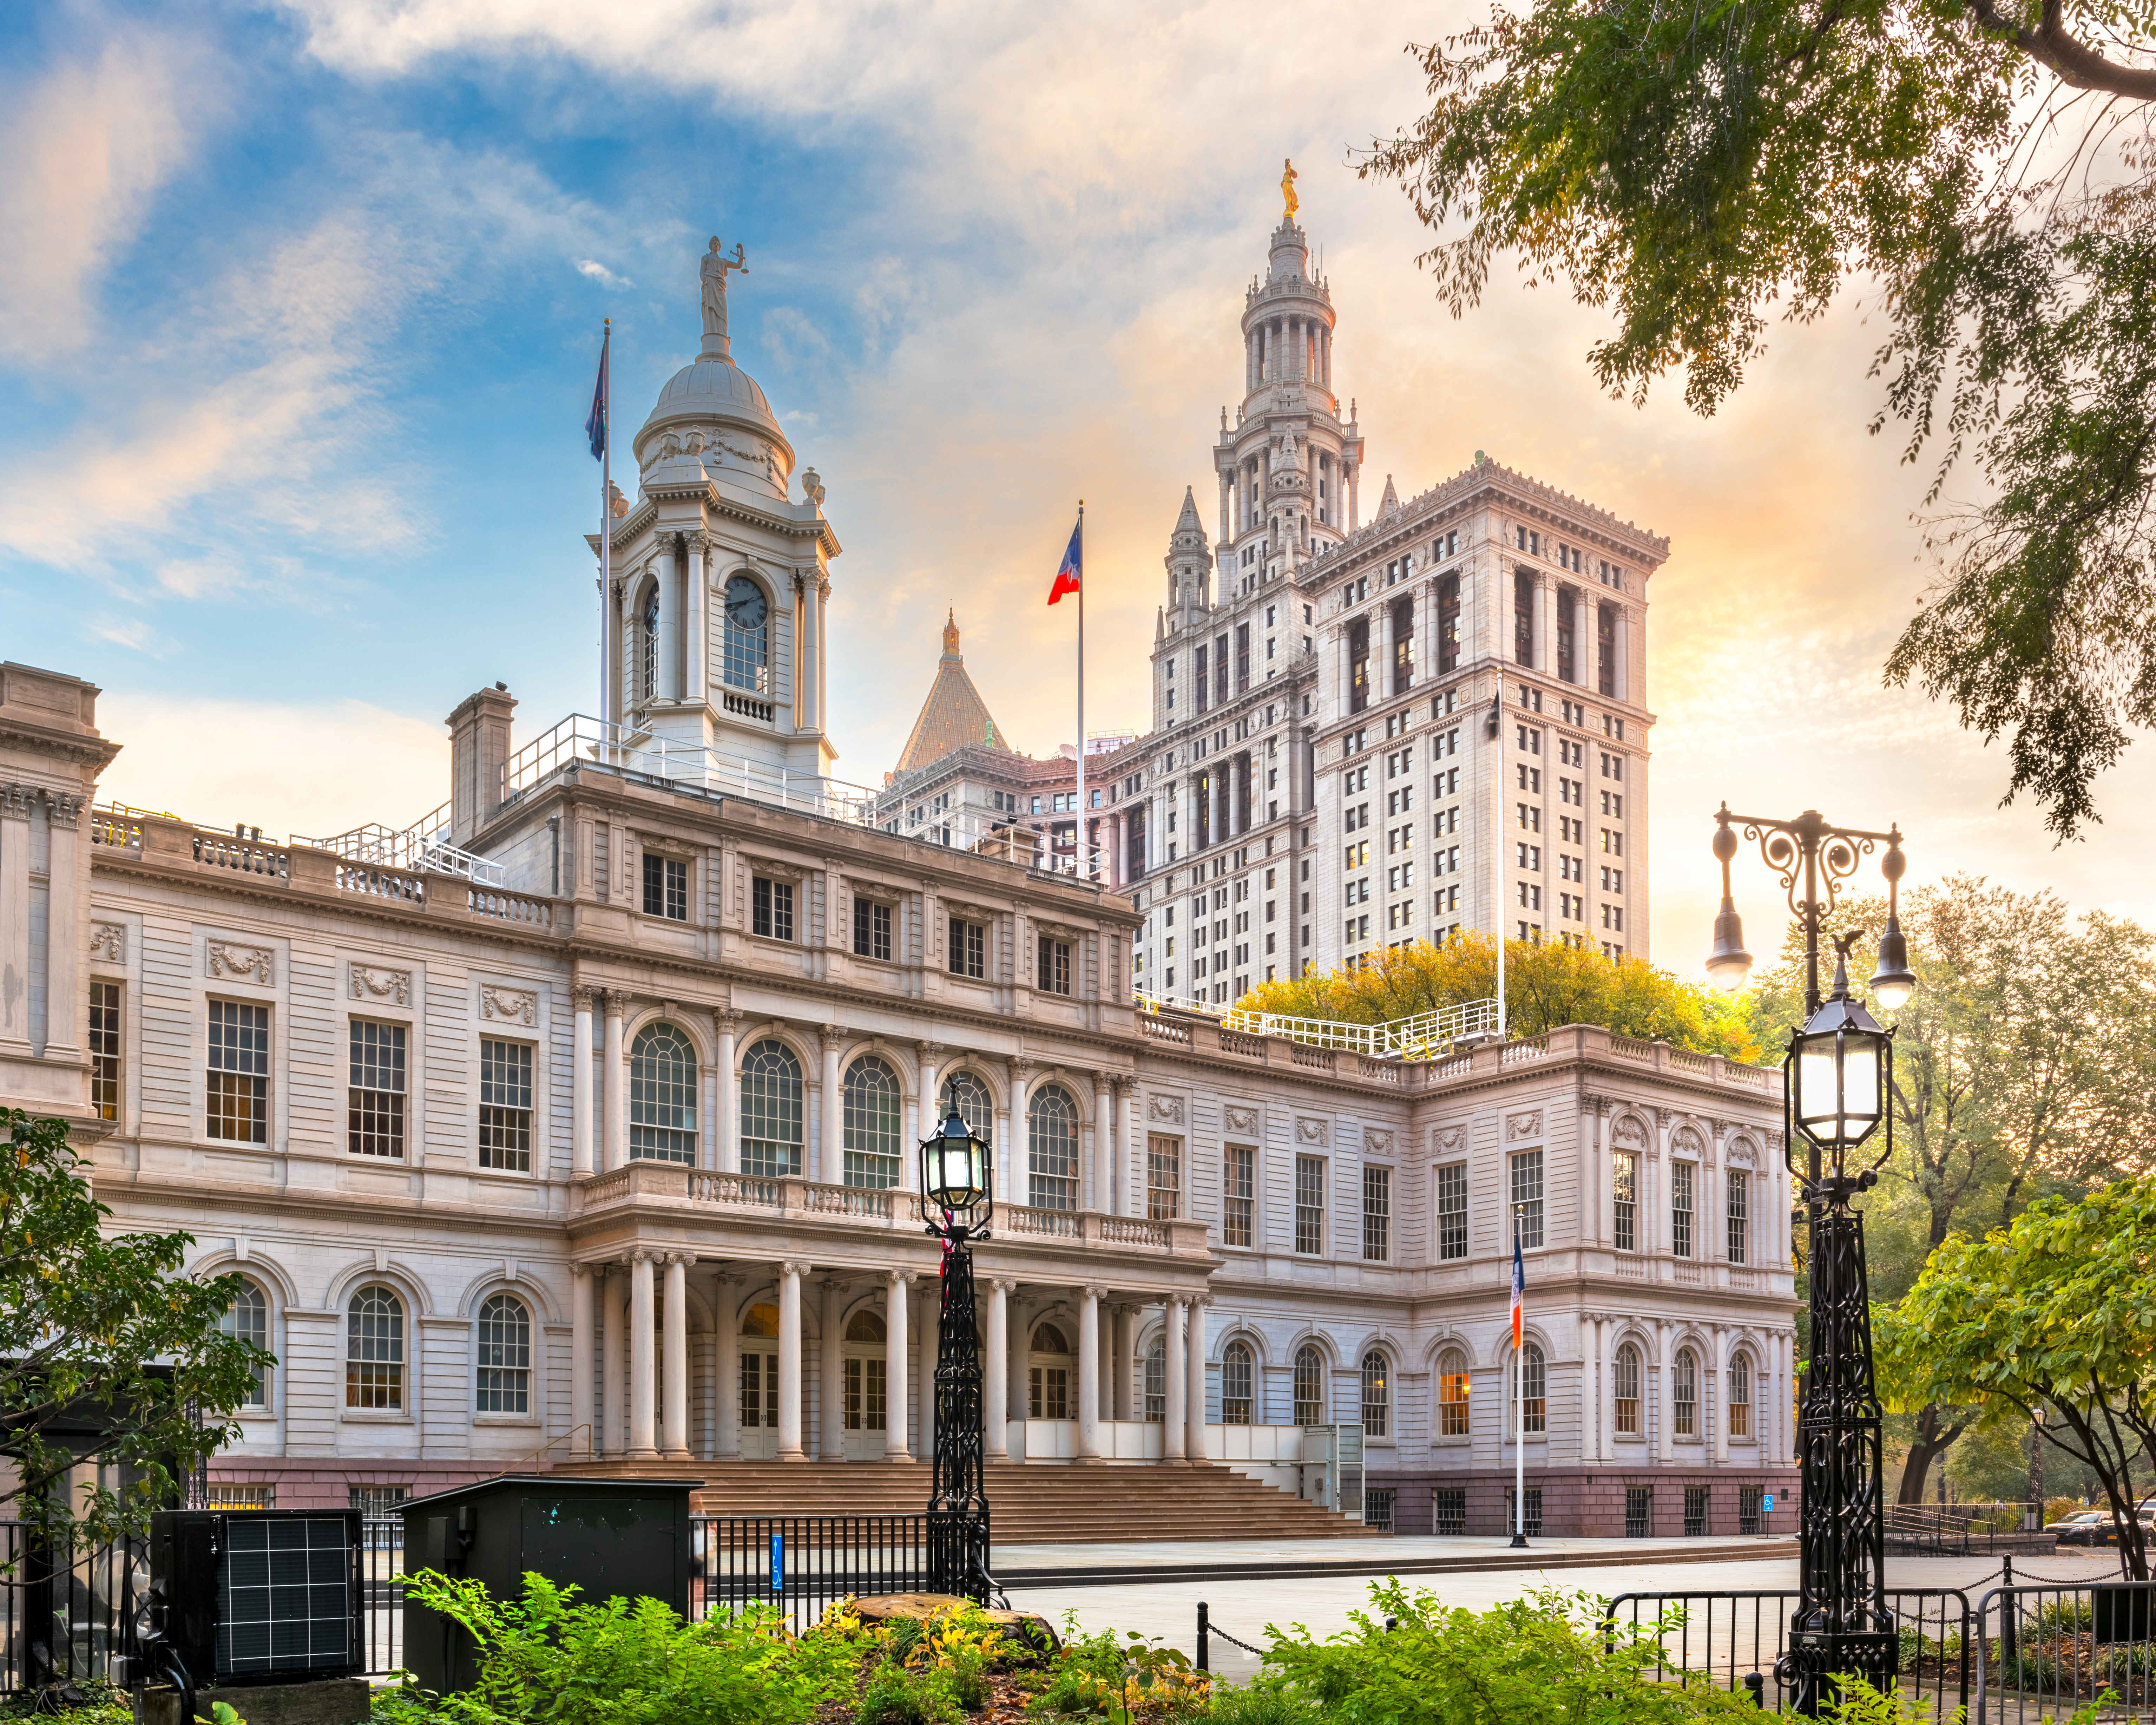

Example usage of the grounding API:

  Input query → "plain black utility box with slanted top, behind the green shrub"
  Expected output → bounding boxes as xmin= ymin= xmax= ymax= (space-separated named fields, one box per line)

xmin=397 ymin=1473 xmax=703 ymax=1695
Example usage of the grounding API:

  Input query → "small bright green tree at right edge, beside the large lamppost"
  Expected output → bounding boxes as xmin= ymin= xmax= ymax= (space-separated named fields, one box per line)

xmin=1876 ymin=1180 xmax=2156 ymax=1578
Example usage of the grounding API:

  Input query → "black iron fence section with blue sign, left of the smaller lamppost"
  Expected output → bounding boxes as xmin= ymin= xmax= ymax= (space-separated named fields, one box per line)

xmin=690 ymin=1516 xmax=929 ymax=1630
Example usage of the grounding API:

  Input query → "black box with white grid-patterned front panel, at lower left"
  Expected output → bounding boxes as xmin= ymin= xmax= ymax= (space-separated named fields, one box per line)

xmin=149 ymin=1509 xmax=367 ymax=1686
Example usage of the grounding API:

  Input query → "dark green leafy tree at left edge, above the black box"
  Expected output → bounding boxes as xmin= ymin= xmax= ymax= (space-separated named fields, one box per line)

xmin=0 ymin=1108 xmax=274 ymax=1544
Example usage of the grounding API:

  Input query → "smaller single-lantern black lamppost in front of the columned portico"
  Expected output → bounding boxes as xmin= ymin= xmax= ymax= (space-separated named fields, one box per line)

xmin=921 ymin=1100 xmax=996 ymax=1604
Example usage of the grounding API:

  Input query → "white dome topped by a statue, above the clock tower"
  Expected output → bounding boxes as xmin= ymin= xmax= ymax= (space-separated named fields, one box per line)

xmin=636 ymin=240 xmax=794 ymax=503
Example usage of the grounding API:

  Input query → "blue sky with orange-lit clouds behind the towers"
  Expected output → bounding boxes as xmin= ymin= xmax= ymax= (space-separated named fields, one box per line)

xmin=0 ymin=0 xmax=2156 ymax=970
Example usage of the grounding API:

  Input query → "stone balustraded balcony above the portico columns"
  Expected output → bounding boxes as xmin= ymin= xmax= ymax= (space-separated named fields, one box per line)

xmin=569 ymin=1162 xmax=1210 ymax=1257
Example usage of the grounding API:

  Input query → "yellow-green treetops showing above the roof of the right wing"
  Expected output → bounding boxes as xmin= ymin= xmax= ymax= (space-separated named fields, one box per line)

xmin=1237 ymin=929 xmax=1759 ymax=1061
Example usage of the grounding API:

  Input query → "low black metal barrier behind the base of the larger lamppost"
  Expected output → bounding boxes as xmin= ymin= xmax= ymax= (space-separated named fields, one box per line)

xmin=1606 ymin=1587 xmax=1977 ymax=1721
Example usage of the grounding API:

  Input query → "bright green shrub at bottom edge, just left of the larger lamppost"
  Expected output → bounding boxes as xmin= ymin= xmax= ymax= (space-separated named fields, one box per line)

xmin=1259 ymin=1581 xmax=1757 ymax=1725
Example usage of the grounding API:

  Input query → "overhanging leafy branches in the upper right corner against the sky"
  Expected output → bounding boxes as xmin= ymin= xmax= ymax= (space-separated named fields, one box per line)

xmin=1358 ymin=0 xmax=2156 ymax=839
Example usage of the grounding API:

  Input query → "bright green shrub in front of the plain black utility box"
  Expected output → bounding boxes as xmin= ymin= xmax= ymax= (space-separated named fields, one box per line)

xmin=377 ymin=1572 xmax=860 ymax=1725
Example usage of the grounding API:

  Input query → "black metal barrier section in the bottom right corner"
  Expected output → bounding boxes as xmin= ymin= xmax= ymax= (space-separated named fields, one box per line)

xmin=1975 ymin=1578 xmax=2156 ymax=1725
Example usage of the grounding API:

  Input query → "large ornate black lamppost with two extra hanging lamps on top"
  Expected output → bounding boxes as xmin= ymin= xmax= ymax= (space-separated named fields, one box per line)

xmin=1708 ymin=802 xmax=1917 ymax=1716
